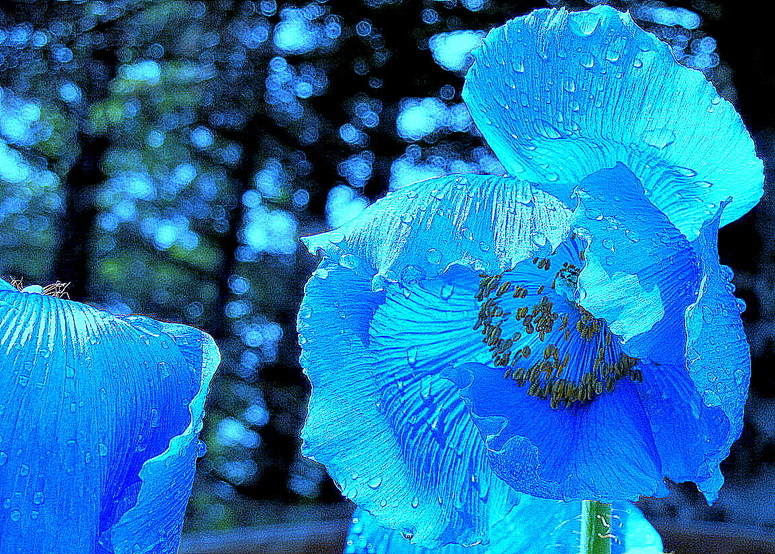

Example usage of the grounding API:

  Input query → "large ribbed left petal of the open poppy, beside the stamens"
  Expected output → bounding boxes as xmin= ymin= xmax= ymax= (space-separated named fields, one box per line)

xmin=299 ymin=259 xmax=515 ymax=547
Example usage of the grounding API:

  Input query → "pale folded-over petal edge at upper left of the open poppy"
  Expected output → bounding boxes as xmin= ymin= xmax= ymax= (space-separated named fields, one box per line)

xmin=302 ymin=175 xmax=569 ymax=282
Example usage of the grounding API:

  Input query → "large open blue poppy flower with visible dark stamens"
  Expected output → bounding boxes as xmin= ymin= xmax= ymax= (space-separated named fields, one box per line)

xmin=299 ymin=6 xmax=763 ymax=548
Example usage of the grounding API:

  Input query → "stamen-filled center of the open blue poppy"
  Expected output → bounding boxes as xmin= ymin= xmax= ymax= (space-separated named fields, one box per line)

xmin=474 ymin=241 xmax=642 ymax=408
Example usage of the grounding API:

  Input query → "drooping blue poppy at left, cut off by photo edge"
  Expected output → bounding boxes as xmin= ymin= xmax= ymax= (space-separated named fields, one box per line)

xmin=0 ymin=281 xmax=219 ymax=554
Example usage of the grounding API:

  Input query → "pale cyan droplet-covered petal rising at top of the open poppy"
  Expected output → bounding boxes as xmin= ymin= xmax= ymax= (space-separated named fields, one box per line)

xmin=463 ymin=6 xmax=763 ymax=239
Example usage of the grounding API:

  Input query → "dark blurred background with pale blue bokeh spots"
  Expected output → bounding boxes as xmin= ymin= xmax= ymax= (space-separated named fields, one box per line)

xmin=0 ymin=0 xmax=775 ymax=553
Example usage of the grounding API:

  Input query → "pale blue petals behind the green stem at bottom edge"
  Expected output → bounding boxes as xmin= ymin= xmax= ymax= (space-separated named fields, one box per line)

xmin=344 ymin=495 xmax=663 ymax=554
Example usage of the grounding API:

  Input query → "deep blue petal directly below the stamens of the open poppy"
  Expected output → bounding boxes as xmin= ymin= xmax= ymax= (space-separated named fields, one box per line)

xmin=446 ymin=363 xmax=668 ymax=502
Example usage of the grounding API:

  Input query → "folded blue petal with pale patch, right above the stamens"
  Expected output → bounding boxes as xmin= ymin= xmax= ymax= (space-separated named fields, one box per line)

xmin=573 ymin=164 xmax=701 ymax=364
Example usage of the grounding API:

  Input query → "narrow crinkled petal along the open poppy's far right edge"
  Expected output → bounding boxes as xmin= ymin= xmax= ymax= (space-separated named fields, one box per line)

xmin=686 ymin=202 xmax=751 ymax=500
